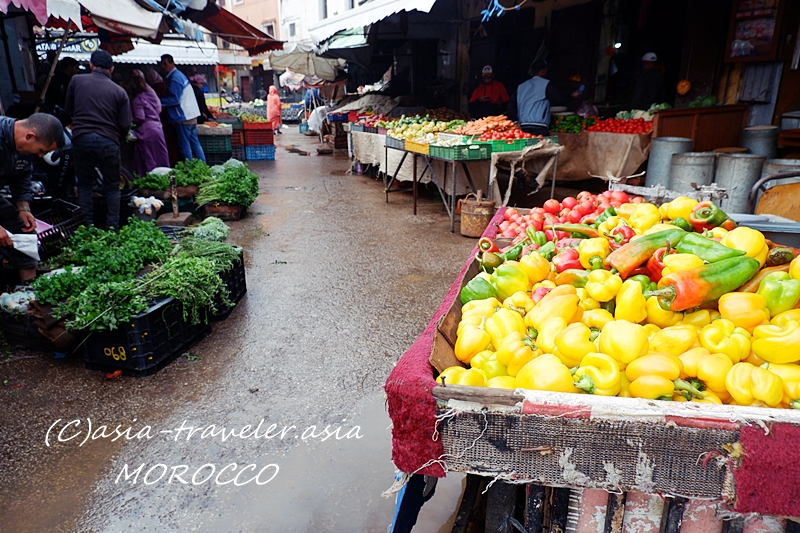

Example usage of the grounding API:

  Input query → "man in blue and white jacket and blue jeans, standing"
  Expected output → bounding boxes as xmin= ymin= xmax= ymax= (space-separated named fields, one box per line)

xmin=159 ymin=54 xmax=206 ymax=163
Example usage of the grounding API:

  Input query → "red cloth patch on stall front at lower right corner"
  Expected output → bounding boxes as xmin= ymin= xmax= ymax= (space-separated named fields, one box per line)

xmin=733 ymin=424 xmax=800 ymax=516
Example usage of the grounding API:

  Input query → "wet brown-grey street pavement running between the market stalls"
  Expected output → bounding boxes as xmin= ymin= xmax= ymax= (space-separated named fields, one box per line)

xmin=0 ymin=125 xmax=475 ymax=533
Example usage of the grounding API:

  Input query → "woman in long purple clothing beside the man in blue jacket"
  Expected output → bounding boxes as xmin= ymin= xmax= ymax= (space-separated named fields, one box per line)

xmin=131 ymin=70 xmax=169 ymax=176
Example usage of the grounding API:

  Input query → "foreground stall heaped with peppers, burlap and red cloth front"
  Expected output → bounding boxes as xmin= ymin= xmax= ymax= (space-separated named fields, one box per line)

xmin=385 ymin=191 xmax=800 ymax=531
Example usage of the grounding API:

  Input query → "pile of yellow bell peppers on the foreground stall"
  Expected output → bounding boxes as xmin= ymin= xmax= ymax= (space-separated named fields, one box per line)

xmin=437 ymin=197 xmax=800 ymax=408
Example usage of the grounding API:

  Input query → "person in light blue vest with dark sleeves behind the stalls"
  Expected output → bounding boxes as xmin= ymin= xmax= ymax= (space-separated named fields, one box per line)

xmin=508 ymin=59 xmax=581 ymax=135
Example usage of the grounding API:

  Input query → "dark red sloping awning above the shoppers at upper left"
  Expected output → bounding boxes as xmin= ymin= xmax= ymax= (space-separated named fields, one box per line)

xmin=181 ymin=2 xmax=283 ymax=55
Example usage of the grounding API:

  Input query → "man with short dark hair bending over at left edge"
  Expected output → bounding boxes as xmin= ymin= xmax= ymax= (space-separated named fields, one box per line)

xmin=0 ymin=113 xmax=64 ymax=282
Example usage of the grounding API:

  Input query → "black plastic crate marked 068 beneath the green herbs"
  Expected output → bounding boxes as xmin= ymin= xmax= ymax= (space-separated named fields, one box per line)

xmin=84 ymin=298 xmax=211 ymax=377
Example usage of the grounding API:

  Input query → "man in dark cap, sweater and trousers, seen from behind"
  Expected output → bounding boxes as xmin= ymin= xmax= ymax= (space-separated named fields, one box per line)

xmin=65 ymin=50 xmax=131 ymax=229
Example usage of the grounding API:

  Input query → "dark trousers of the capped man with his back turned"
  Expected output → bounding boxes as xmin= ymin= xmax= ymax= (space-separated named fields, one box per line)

xmin=72 ymin=133 xmax=120 ymax=229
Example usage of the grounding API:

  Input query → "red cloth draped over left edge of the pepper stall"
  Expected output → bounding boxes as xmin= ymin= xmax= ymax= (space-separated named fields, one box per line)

xmin=384 ymin=207 xmax=506 ymax=477
